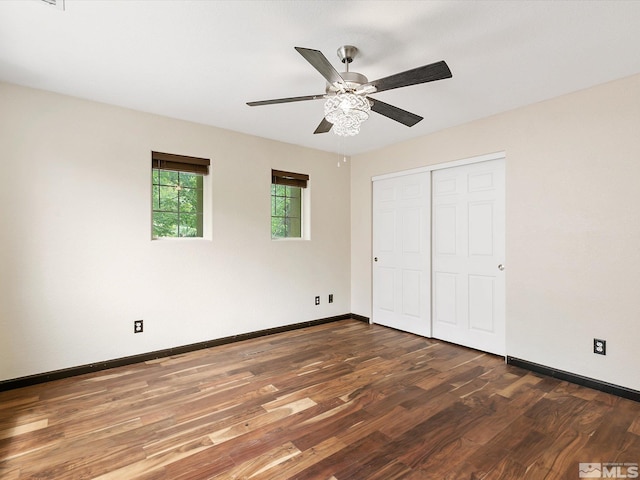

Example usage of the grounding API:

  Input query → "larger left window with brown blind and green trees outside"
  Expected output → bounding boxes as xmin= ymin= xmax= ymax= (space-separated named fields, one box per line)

xmin=151 ymin=152 xmax=210 ymax=238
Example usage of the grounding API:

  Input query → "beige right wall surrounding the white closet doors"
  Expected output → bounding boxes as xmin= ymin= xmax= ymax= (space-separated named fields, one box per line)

xmin=351 ymin=75 xmax=640 ymax=390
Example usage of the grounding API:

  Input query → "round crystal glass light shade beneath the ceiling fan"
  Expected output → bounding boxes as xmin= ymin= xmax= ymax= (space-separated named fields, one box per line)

xmin=324 ymin=93 xmax=371 ymax=137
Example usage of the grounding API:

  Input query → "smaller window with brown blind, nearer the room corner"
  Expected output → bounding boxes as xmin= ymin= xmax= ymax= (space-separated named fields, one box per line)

xmin=271 ymin=170 xmax=309 ymax=238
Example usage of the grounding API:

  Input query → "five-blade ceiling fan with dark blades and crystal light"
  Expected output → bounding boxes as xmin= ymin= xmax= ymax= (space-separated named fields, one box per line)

xmin=247 ymin=45 xmax=452 ymax=136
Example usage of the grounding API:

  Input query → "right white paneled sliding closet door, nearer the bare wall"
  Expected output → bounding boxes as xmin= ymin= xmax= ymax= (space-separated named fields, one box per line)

xmin=432 ymin=160 xmax=505 ymax=355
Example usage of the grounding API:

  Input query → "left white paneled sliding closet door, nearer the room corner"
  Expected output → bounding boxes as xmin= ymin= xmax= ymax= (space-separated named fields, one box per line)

xmin=372 ymin=172 xmax=431 ymax=336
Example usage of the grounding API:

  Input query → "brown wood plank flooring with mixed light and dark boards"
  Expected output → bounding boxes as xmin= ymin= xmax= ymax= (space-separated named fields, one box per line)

xmin=0 ymin=320 xmax=640 ymax=480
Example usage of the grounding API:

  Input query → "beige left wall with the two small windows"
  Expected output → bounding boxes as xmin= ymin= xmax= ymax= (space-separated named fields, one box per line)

xmin=0 ymin=84 xmax=350 ymax=380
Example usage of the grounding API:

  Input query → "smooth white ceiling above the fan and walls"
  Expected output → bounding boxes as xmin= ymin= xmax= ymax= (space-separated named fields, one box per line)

xmin=0 ymin=0 xmax=640 ymax=155
